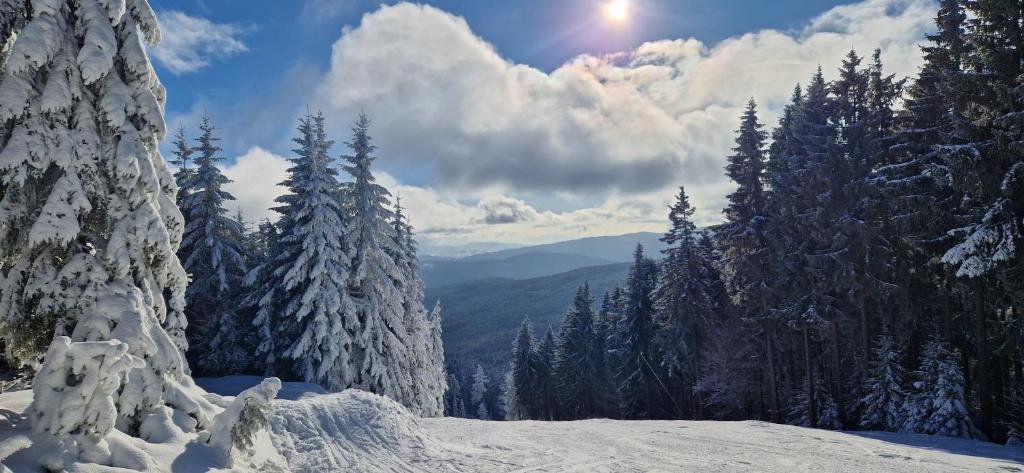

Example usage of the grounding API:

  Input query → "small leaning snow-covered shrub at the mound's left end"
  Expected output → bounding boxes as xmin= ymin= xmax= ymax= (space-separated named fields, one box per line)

xmin=204 ymin=378 xmax=281 ymax=465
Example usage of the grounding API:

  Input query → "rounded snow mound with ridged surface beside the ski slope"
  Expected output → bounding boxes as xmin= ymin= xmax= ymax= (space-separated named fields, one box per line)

xmin=269 ymin=389 xmax=447 ymax=472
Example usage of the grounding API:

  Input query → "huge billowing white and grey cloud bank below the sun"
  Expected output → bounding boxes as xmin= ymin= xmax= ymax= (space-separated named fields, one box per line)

xmin=309 ymin=0 xmax=936 ymax=231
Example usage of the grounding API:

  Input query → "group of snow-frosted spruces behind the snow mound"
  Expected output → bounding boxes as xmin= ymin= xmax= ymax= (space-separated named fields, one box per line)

xmin=96 ymin=115 xmax=445 ymax=416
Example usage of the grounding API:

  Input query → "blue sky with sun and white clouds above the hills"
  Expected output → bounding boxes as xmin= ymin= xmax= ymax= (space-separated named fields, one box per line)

xmin=152 ymin=0 xmax=935 ymax=249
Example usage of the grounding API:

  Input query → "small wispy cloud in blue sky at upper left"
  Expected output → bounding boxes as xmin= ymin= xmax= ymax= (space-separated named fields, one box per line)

xmin=153 ymin=10 xmax=249 ymax=75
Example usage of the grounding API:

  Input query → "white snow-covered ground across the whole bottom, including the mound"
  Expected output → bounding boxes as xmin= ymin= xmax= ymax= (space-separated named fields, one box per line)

xmin=0 ymin=377 xmax=1024 ymax=472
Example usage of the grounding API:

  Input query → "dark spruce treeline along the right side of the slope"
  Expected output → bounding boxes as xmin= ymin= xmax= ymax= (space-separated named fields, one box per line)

xmin=508 ymin=0 xmax=1024 ymax=441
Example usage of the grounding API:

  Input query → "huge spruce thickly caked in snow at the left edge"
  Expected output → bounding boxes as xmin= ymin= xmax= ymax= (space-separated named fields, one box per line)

xmin=0 ymin=0 xmax=220 ymax=442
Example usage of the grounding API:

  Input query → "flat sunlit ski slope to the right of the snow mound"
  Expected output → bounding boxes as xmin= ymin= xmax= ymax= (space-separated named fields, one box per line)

xmin=420 ymin=419 xmax=1024 ymax=473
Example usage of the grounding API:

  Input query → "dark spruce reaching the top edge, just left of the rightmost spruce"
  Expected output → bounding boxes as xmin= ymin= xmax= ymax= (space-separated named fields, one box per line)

xmin=874 ymin=0 xmax=967 ymax=341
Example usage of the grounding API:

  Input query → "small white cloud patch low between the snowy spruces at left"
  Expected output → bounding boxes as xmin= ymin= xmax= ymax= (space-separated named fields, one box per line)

xmin=222 ymin=146 xmax=289 ymax=221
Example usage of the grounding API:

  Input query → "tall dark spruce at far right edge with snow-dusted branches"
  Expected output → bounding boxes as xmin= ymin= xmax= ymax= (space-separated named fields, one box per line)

xmin=942 ymin=0 xmax=1024 ymax=437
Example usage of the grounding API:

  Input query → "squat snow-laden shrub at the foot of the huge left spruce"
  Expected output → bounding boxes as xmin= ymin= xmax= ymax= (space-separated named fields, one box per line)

xmin=28 ymin=337 xmax=144 ymax=467
